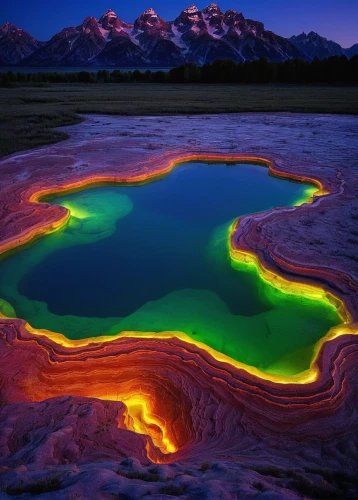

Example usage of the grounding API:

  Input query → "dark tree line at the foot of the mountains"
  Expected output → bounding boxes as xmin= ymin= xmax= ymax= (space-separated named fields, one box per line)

xmin=0 ymin=54 xmax=358 ymax=87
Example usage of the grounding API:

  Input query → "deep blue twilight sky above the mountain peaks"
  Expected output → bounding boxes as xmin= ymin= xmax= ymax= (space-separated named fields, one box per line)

xmin=0 ymin=0 xmax=358 ymax=47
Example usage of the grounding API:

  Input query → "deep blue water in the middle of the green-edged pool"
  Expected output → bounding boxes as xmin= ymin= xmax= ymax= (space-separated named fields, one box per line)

xmin=19 ymin=163 xmax=306 ymax=317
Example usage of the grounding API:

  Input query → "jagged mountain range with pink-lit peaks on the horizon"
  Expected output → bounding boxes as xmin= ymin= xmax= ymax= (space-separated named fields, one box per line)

xmin=0 ymin=3 xmax=358 ymax=67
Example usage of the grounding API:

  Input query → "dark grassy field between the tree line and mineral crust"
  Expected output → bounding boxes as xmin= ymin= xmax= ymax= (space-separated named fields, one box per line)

xmin=0 ymin=83 xmax=358 ymax=156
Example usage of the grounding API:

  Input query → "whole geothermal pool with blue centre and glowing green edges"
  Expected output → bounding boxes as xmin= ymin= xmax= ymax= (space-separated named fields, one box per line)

xmin=0 ymin=162 xmax=341 ymax=375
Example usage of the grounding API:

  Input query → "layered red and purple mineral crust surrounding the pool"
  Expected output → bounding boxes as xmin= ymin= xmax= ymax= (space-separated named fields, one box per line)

xmin=0 ymin=114 xmax=358 ymax=498
